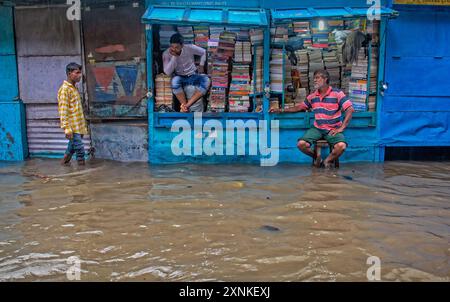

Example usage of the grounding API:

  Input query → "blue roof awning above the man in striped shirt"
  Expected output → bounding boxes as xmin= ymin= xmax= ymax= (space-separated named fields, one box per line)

xmin=271 ymin=7 xmax=397 ymax=23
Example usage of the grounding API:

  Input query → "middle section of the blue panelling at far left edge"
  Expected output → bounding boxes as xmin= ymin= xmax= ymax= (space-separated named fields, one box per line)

xmin=0 ymin=55 xmax=19 ymax=101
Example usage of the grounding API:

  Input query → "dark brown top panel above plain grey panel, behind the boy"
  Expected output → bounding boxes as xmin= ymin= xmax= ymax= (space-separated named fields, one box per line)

xmin=15 ymin=7 xmax=81 ymax=56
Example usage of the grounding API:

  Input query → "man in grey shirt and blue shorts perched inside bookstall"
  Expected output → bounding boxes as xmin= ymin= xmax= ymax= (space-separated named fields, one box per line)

xmin=163 ymin=33 xmax=211 ymax=112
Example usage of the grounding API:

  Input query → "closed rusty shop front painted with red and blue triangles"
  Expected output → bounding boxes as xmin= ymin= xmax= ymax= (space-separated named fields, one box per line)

xmin=82 ymin=2 xmax=148 ymax=161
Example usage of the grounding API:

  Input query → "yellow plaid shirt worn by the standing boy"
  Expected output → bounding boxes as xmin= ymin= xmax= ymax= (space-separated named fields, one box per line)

xmin=58 ymin=81 xmax=88 ymax=134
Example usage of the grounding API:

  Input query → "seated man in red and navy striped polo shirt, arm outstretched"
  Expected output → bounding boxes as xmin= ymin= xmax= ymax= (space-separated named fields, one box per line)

xmin=271 ymin=70 xmax=354 ymax=168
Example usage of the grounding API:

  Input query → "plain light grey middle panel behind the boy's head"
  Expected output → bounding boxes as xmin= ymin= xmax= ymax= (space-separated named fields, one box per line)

xmin=18 ymin=56 xmax=82 ymax=103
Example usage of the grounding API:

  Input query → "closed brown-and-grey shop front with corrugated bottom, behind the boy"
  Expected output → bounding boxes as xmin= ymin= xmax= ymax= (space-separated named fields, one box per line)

xmin=15 ymin=6 xmax=90 ymax=156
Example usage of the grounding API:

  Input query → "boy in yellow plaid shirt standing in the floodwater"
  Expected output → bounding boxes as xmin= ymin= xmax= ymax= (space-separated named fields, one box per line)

xmin=58 ymin=63 xmax=87 ymax=165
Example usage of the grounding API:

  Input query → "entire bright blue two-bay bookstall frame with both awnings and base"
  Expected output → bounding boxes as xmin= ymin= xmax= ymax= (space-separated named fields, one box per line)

xmin=143 ymin=0 xmax=395 ymax=163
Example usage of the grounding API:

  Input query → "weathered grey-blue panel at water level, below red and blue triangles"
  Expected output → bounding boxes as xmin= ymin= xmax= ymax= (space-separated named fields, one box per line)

xmin=91 ymin=121 xmax=148 ymax=161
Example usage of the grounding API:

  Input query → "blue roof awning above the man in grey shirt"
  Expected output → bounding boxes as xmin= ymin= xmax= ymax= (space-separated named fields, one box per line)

xmin=142 ymin=5 xmax=269 ymax=27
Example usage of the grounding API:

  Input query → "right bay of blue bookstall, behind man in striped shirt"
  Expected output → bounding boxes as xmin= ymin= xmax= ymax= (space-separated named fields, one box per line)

xmin=265 ymin=1 xmax=396 ymax=162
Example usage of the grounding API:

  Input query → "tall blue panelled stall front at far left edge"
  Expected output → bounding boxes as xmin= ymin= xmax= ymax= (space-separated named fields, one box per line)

xmin=0 ymin=5 xmax=28 ymax=161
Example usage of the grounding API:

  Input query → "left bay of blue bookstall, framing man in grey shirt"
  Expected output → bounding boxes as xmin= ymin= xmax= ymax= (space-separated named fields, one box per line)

xmin=143 ymin=5 xmax=269 ymax=163
